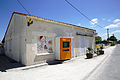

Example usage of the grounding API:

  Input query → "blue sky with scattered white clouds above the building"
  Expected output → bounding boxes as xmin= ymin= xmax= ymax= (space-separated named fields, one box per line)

xmin=0 ymin=0 xmax=120 ymax=41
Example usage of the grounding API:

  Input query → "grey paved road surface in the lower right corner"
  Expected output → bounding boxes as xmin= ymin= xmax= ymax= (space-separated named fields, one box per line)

xmin=86 ymin=45 xmax=120 ymax=80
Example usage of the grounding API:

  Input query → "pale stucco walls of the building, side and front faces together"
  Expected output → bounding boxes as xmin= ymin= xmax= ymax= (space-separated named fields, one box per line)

xmin=5 ymin=14 xmax=94 ymax=65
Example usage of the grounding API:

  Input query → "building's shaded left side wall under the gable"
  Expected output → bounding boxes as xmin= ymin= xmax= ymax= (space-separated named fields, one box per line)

xmin=5 ymin=14 xmax=26 ymax=64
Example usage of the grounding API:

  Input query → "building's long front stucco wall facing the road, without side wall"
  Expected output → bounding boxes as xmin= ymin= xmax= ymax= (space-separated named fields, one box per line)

xmin=26 ymin=15 xmax=93 ymax=64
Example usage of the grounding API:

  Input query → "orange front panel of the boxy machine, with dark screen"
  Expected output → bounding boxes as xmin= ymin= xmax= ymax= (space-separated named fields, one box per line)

xmin=60 ymin=38 xmax=72 ymax=60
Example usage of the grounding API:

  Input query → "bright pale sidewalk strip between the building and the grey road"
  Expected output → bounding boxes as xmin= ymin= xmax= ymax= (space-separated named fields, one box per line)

xmin=0 ymin=47 xmax=114 ymax=80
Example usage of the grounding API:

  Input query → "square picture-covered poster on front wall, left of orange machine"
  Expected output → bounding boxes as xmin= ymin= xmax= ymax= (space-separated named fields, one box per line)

xmin=37 ymin=36 xmax=53 ymax=53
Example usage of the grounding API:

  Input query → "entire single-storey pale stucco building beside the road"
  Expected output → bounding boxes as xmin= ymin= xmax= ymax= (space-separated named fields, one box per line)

xmin=3 ymin=12 xmax=96 ymax=65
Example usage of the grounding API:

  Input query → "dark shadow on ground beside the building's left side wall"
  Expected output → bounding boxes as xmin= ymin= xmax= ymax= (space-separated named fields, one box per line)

xmin=0 ymin=55 xmax=24 ymax=72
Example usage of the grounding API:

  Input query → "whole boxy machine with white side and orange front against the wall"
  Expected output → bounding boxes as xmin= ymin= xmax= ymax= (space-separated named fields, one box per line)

xmin=56 ymin=37 xmax=72 ymax=60
